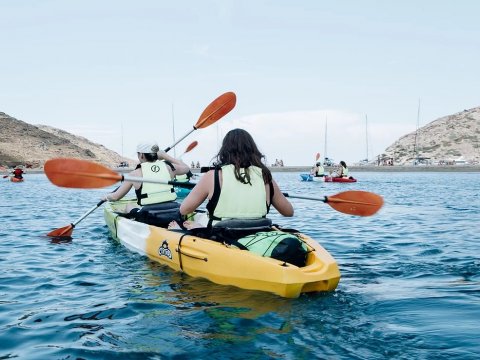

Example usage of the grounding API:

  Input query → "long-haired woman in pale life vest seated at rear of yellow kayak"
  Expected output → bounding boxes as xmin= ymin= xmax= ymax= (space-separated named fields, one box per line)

xmin=171 ymin=129 xmax=293 ymax=228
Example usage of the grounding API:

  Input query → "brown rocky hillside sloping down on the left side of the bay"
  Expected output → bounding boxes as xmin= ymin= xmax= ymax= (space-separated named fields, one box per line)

xmin=0 ymin=112 xmax=131 ymax=168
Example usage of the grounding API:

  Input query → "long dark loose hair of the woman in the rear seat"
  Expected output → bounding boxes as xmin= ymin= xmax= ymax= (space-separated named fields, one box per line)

xmin=217 ymin=129 xmax=272 ymax=184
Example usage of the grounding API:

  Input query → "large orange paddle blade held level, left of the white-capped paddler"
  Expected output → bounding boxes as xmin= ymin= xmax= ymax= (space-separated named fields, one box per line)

xmin=44 ymin=158 xmax=123 ymax=189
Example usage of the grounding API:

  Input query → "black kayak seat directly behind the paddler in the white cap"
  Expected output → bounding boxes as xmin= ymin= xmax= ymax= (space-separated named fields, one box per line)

xmin=133 ymin=201 xmax=182 ymax=228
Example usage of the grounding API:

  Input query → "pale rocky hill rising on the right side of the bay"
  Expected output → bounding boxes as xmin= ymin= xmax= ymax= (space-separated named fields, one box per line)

xmin=380 ymin=107 xmax=480 ymax=165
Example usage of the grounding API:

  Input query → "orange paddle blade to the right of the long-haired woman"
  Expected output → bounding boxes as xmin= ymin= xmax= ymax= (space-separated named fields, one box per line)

xmin=325 ymin=190 xmax=383 ymax=216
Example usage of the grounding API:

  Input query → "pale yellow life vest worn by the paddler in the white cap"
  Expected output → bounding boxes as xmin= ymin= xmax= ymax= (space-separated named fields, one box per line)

xmin=137 ymin=160 xmax=177 ymax=205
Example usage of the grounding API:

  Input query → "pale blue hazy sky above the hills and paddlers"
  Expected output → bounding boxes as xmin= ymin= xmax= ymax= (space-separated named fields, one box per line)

xmin=0 ymin=0 xmax=480 ymax=165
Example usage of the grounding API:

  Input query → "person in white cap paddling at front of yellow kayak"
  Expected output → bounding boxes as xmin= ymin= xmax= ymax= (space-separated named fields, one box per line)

xmin=102 ymin=141 xmax=190 ymax=212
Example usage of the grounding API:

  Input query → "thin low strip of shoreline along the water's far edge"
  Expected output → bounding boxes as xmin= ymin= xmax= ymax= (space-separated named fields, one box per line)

xmin=13 ymin=165 xmax=480 ymax=175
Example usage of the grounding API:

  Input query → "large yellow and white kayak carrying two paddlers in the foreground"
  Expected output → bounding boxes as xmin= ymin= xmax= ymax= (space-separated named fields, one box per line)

xmin=104 ymin=200 xmax=340 ymax=298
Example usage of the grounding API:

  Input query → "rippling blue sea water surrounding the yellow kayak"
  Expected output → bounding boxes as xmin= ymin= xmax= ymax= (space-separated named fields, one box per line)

xmin=0 ymin=173 xmax=480 ymax=359
